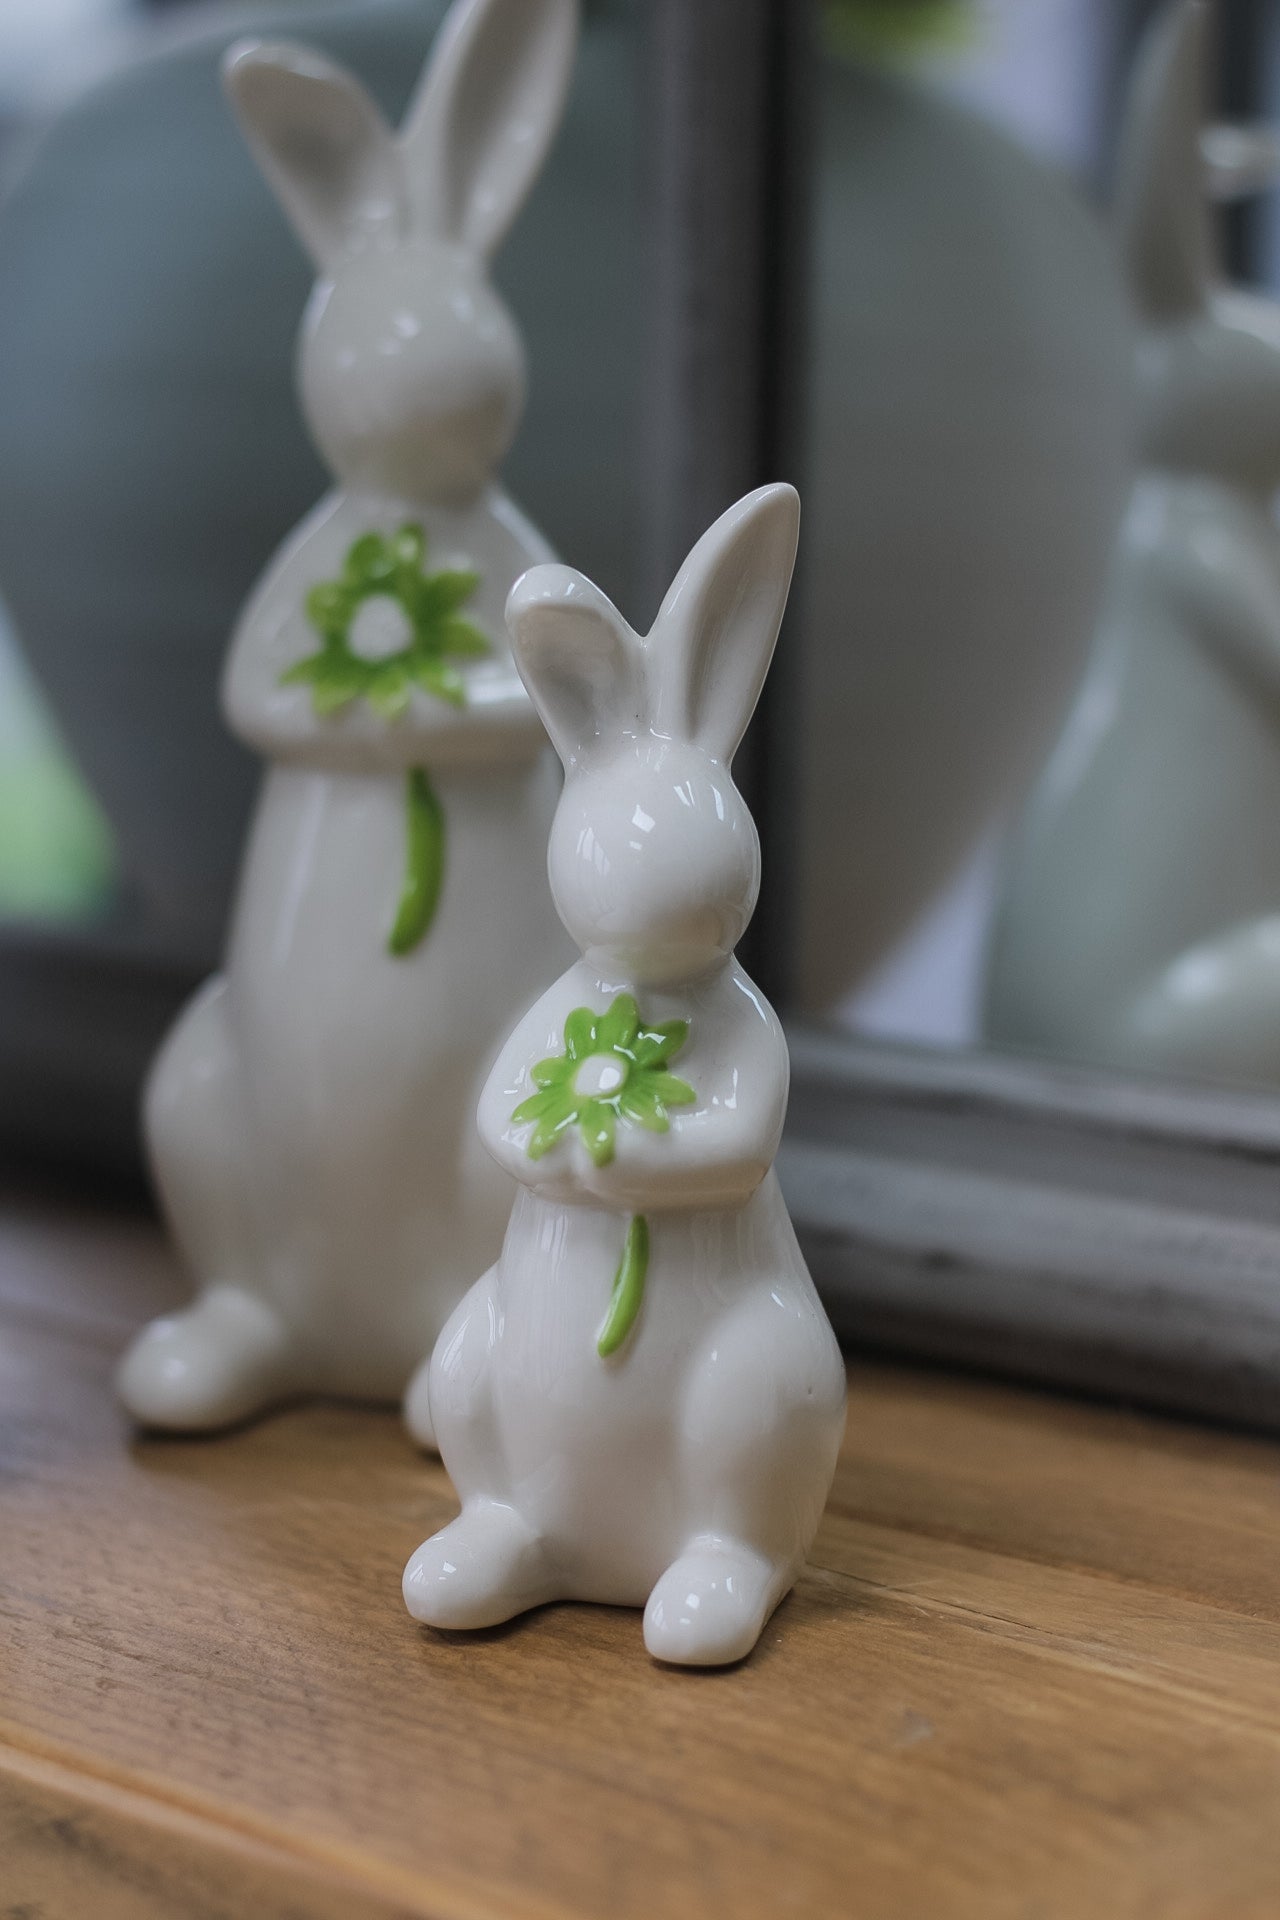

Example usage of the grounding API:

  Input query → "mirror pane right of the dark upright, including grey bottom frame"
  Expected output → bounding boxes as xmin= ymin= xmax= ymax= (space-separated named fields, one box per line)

xmin=785 ymin=0 xmax=1280 ymax=1425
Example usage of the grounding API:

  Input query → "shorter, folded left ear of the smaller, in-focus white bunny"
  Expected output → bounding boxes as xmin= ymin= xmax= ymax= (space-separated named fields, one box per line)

xmin=507 ymin=564 xmax=643 ymax=772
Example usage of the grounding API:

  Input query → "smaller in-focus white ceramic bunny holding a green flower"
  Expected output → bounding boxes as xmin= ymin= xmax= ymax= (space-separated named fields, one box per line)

xmin=405 ymin=486 xmax=844 ymax=1667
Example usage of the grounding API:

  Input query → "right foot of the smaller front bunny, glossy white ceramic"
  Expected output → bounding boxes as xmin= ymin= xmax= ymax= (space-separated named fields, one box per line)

xmin=645 ymin=1538 xmax=791 ymax=1667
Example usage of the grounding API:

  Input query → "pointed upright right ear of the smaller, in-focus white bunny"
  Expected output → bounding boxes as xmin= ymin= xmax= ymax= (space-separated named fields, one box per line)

xmin=649 ymin=486 xmax=800 ymax=766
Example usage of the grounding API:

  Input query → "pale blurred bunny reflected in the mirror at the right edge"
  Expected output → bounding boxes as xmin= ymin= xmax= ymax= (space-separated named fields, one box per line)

xmin=986 ymin=0 xmax=1280 ymax=1081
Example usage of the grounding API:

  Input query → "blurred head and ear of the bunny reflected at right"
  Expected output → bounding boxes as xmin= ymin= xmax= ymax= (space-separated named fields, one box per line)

xmin=1117 ymin=0 xmax=1280 ymax=493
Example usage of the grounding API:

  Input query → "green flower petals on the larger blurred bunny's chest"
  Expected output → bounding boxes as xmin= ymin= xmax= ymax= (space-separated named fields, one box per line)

xmin=280 ymin=526 xmax=489 ymax=720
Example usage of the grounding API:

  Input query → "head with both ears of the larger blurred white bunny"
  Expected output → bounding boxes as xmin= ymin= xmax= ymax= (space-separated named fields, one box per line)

xmin=225 ymin=0 xmax=578 ymax=505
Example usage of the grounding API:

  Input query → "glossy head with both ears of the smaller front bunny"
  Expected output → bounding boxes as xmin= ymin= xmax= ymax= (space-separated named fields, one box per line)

xmin=507 ymin=486 xmax=800 ymax=987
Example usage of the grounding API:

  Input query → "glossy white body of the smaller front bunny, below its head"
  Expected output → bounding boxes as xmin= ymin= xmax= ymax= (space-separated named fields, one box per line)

xmin=409 ymin=968 xmax=844 ymax=1628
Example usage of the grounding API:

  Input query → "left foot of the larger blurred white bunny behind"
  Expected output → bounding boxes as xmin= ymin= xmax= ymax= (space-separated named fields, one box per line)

xmin=115 ymin=1286 xmax=297 ymax=1432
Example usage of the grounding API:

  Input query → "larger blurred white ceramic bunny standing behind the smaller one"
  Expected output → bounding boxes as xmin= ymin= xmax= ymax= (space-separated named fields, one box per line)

xmin=119 ymin=0 xmax=578 ymax=1428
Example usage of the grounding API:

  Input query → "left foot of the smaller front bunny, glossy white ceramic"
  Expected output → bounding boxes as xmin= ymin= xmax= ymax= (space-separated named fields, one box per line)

xmin=403 ymin=1500 xmax=557 ymax=1628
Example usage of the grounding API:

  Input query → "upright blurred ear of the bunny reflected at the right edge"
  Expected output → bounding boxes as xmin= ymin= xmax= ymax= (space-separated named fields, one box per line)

xmin=1117 ymin=0 xmax=1215 ymax=319
